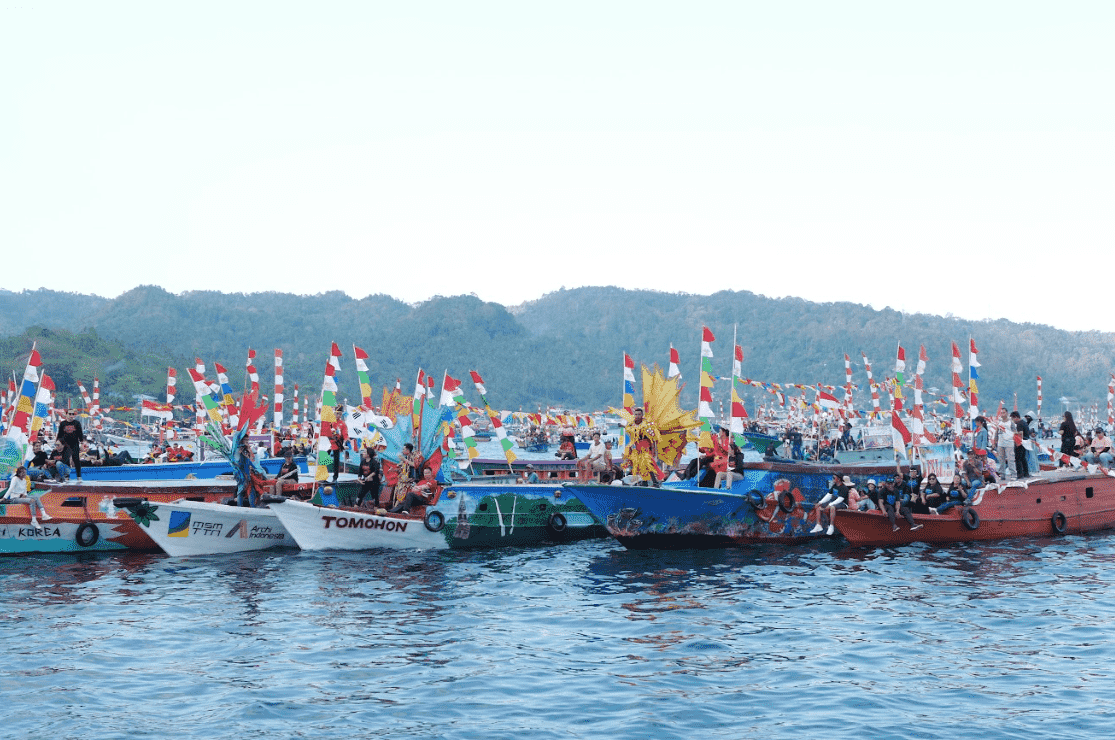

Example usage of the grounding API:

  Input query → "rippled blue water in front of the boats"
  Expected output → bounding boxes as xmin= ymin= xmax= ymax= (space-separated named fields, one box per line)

xmin=0 ymin=535 xmax=1115 ymax=740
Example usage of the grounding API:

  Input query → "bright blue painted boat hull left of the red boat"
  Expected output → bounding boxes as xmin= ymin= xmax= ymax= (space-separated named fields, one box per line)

xmin=565 ymin=461 xmax=932 ymax=549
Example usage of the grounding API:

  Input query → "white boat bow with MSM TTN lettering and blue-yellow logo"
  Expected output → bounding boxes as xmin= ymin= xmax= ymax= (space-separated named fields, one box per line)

xmin=131 ymin=498 xmax=298 ymax=556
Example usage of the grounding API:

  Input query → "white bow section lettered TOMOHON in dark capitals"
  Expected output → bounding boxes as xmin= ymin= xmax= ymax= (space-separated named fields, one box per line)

xmin=271 ymin=500 xmax=449 ymax=549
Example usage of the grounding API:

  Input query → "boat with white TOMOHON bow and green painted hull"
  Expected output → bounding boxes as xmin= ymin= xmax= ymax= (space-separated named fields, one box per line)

xmin=271 ymin=484 xmax=605 ymax=549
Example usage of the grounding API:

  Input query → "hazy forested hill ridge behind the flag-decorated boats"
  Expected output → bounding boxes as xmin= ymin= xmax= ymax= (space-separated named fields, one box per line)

xmin=0 ymin=286 xmax=1115 ymax=417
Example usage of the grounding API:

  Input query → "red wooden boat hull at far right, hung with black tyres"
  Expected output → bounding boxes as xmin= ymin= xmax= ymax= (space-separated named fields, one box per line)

xmin=835 ymin=468 xmax=1115 ymax=547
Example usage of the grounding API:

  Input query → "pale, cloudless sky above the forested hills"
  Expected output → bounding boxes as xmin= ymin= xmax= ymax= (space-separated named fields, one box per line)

xmin=0 ymin=0 xmax=1115 ymax=331
